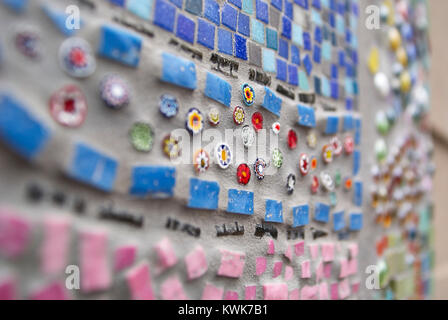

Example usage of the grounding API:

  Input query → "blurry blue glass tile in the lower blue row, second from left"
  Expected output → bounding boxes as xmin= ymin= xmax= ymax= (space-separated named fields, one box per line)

xmin=68 ymin=143 xmax=118 ymax=191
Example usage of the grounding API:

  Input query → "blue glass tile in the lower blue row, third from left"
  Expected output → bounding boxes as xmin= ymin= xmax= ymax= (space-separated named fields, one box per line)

xmin=129 ymin=166 xmax=176 ymax=198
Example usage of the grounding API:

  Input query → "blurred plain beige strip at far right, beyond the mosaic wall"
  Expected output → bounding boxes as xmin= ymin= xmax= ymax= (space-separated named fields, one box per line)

xmin=428 ymin=0 xmax=448 ymax=299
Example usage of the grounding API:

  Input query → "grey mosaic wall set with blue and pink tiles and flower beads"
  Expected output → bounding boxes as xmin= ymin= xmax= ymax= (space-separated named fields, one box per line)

xmin=0 ymin=0 xmax=433 ymax=300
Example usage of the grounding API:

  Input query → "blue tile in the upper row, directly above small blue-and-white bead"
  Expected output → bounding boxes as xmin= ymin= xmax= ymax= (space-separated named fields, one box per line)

xmin=161 ymin=52 xmax=197 ymax=90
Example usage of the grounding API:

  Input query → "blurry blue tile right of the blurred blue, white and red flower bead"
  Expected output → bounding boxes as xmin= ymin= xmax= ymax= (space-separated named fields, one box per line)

xmin=98 ymin=25 xmax=142 ymax=67
